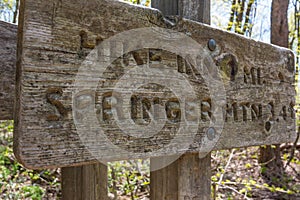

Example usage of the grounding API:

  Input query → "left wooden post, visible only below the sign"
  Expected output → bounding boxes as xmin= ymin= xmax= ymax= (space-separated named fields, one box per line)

xmin=62 ymin=163 xmax=107 ymax=200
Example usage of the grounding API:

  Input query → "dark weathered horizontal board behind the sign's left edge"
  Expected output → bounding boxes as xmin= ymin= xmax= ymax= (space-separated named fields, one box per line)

xmin=0 ymin=21 xmax=17 ymax=120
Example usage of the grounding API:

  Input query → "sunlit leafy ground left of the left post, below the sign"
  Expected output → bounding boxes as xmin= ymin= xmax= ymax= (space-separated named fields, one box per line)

xmin=0 ymin=121 xmax=60 ymax=200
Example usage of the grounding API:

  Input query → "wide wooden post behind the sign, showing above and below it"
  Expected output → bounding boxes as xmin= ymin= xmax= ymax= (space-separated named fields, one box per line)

xmin=150 ymin=0 xmax=211 ymax=200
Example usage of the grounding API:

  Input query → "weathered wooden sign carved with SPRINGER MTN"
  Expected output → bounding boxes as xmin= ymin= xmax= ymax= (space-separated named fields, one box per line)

xmin=14 ymin=0 xmax=295 ymax=168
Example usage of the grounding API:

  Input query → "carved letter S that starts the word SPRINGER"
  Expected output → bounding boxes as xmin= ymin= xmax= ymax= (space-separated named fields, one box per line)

xmin=46 ymin=88 xmax=68 ymax=121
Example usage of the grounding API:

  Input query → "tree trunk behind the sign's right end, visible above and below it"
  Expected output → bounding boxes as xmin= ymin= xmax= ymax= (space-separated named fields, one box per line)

xmin=259 ymin=0 xmax=289 ymax=174
